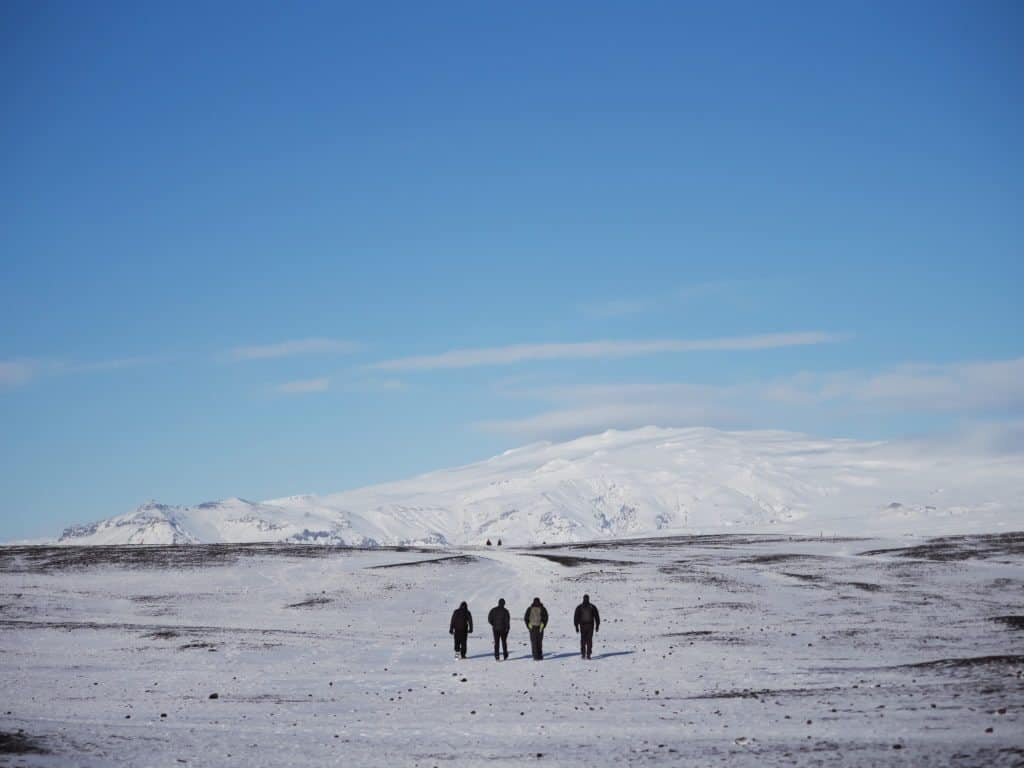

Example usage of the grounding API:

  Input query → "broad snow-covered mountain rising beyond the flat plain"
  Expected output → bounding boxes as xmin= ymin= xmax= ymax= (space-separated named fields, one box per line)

xmin=59 ymin=427 xmax=1024 ymax=546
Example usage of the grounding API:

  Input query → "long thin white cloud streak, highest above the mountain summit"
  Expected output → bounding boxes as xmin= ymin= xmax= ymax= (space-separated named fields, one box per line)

xmin=369 ymin=331 xmax=847 ymax=371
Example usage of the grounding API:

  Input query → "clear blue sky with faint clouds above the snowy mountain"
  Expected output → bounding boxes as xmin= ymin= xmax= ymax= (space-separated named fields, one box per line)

xmin=0 ymin=2 xmax=1024 ymax=538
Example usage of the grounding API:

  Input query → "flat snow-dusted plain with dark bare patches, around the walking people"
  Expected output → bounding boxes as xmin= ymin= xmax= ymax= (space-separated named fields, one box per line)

xmin=0 ymin=534 xmax=1024 ymax=767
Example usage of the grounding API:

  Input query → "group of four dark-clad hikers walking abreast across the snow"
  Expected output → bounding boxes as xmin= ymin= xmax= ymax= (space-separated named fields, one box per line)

xmin=449 ymin=595 xmax=601 ymax=662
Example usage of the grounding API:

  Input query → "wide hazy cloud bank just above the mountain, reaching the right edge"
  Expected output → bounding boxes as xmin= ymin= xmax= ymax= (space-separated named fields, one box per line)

xmin=475 ymin=357 xmax=1024 ymax=437
